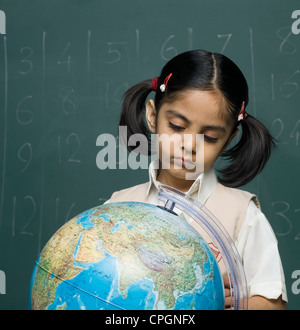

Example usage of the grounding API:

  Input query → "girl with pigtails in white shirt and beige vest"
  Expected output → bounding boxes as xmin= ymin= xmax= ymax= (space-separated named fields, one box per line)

xmin=108 ymin=50 xmax=287 ymax=309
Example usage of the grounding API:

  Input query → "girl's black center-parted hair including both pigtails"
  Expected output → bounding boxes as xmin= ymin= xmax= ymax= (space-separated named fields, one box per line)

xmin=120 ymin=50 xmax=274 ymax=187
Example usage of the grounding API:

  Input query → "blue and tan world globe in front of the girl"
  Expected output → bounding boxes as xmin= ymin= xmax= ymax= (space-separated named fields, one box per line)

xmin=29 ymin=202 xmax=224 ymax=310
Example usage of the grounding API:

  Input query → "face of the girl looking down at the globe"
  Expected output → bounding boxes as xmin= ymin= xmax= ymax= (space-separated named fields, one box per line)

xmin=146 ymin=90 xmax=238 ymax=191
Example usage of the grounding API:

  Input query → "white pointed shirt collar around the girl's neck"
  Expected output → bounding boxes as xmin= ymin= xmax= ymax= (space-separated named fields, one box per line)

xmin=147 ymin=159 xmax=218 ymax=204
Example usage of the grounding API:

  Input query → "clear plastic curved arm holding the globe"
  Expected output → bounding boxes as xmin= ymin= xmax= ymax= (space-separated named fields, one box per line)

xmin=159 ymin=184 xmax=248 ymax=310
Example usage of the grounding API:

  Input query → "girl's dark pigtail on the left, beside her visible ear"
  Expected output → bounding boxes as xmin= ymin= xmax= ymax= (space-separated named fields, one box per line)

xmin=120 ymin=79 xmax=152 ymax=154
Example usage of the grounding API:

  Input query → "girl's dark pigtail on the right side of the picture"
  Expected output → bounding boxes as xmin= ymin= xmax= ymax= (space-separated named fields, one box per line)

xmin=219 ymin=115 xmax=275 ymax=188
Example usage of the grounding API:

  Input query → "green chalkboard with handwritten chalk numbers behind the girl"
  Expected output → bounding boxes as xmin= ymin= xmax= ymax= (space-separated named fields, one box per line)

xmin=0 ymin=0 xmax=300 ymax=309
